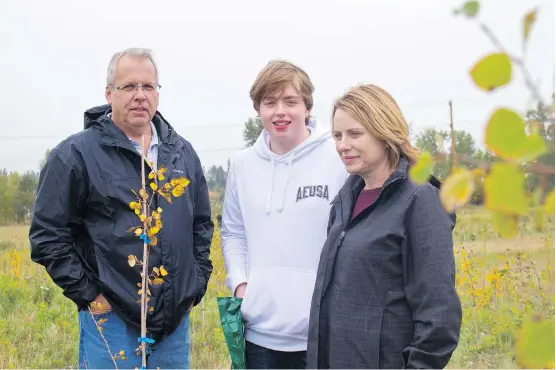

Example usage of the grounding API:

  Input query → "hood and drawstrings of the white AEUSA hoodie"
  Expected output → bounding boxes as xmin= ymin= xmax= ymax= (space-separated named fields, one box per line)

xmin=253 ymin=119 xmax=331 ymax=215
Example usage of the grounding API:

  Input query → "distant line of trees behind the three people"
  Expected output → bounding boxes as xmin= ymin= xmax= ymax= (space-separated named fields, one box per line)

xmin=0 ymin=99 xmax=555 ymax=225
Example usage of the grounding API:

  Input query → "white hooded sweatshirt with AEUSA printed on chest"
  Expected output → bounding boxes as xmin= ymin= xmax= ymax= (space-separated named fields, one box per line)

xmin=221 ymin=121 xmax=348 ymax=351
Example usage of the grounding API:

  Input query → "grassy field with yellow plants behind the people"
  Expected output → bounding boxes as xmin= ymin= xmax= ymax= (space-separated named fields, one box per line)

xmin=0 ymin=209 xmax=554 ymax=368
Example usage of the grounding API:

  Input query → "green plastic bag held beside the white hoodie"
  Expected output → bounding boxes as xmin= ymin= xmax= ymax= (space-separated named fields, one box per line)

xmin=216 ymin=297 xmax=246 ymax=369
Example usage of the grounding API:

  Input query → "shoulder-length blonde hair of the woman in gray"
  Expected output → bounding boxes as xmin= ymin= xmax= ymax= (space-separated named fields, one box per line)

xmin=332 ymin=85 xmax=419 ymax=168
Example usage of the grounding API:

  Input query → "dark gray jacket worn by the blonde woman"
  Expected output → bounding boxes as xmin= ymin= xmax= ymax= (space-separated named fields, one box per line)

xmin=307 ymin=158 xmax=462 ymax=369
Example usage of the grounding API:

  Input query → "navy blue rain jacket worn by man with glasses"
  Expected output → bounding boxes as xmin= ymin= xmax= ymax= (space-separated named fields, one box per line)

xmin=29 ymin=105 xmax=214 ymax=337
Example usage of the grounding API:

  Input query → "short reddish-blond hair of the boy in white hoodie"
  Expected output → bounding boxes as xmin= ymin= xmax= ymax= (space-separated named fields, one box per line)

xmin=249 ymin=60 xmax=315 ymax=123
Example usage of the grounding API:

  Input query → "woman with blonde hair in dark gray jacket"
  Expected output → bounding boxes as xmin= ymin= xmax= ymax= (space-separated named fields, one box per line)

xmin=307 ymin=85 xmax=462 ymax=369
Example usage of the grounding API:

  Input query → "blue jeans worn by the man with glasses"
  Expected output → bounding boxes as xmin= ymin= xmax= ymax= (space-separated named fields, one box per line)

xmin=78 ymin=311 xmax=191 ymax=369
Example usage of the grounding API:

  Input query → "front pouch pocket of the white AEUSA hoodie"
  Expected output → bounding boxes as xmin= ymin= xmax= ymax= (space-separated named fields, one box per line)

xmin=241 ymin=268 xmax=316 ymax=338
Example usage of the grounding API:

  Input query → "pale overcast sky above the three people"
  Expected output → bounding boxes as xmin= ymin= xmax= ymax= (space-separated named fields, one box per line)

xmin=0 ymin=0 xmax=555 ymax=171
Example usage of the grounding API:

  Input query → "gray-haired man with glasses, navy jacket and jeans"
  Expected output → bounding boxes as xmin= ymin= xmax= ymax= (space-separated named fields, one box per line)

xmin=29 ymin=49 xmax=214 ymax=368
